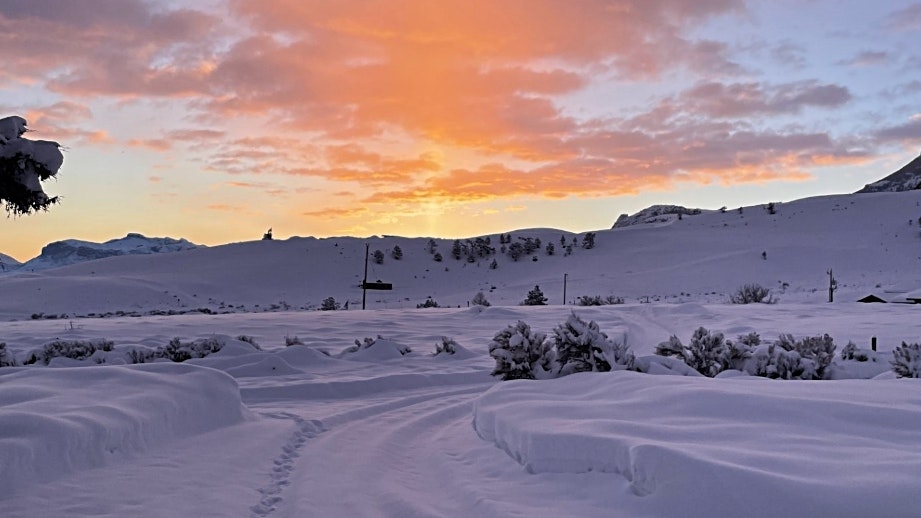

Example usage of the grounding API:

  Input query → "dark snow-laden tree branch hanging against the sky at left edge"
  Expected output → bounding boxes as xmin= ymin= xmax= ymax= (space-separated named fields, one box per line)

xmin=0 ymin=115 xmax=64 ymax=215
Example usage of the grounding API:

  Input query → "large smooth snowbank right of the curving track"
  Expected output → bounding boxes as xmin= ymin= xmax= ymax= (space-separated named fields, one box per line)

xmin=474 ymin=371 xmax=921 ymax=516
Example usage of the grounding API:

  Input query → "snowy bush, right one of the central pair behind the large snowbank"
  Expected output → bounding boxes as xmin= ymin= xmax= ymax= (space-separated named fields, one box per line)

xmin=553 ymin=313 xmax=633 ymax=376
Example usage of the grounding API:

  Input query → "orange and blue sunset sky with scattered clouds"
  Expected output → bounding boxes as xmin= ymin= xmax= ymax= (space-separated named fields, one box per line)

xmin=0 ymin=0 xmax=921 ymax=261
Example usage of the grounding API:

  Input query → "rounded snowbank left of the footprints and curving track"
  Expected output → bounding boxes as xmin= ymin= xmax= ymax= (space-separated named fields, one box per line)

xmin=0 ymin=363 xmax=248 ymax=495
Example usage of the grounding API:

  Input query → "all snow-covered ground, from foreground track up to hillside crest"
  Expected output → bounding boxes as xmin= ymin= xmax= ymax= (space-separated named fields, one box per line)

xmin=0 ymin=189 xmax=921 ymax=517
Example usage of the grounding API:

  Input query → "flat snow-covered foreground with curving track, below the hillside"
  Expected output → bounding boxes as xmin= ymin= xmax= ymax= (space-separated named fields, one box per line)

xmin=0 ymin=303 xmax=921 ymax=517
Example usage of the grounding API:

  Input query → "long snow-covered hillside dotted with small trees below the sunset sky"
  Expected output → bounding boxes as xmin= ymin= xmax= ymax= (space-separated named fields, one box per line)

xmin=0 ymin=191 xmax=921 ymax=318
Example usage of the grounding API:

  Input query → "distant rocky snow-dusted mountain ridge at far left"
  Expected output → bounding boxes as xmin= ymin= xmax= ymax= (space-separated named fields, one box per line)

xmin=0 ymin=233 xmax=203 ymax=273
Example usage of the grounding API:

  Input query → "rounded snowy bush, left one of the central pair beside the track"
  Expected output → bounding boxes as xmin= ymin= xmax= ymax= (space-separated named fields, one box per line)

xmin=489 ymin=320 xmax=555 ymax=381
